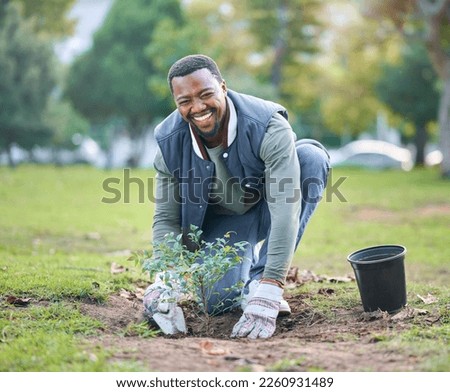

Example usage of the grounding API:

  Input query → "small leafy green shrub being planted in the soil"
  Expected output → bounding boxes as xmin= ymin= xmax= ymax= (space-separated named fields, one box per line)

xmin=131 ymin=226 xmax=248 ymax=333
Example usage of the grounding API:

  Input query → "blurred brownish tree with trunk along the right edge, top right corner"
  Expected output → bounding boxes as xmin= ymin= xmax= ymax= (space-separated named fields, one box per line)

xmin=363 ymin=0 xmax=450 ymax=178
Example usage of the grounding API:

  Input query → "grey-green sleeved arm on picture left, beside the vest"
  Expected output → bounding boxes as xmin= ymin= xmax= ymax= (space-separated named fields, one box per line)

xmin=153 ymin=149 xmax=181 ymax=242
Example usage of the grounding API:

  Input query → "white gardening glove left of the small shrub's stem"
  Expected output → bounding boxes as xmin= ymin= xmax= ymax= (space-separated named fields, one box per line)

xmin=144 ymin=282 xmax=186 ymax=335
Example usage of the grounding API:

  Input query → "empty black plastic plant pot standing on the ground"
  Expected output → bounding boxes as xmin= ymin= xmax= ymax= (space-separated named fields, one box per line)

xmin=347 ymin=245 xmax=406 ymax=313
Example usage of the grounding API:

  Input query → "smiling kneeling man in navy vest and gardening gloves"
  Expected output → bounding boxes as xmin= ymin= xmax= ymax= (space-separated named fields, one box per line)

xmin=144 ymin=55 xmax=329 ymax=339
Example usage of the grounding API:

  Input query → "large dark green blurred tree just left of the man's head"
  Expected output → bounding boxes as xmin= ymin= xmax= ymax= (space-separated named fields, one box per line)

xmin=66 ymin=0 xmax=181 ymax=165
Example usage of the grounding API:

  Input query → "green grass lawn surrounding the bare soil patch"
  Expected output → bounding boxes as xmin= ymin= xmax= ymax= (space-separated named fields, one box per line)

xmin=0 ymin=165 xmax=450 ymax=371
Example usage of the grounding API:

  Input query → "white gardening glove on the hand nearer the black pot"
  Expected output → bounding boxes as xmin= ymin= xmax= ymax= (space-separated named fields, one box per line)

xmin=231 ymin=282 xmax=283 ymax=339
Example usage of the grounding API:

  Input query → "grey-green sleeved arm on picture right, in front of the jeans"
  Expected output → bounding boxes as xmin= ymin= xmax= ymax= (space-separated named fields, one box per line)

xmin=260 ymin=113 xmax=302 ymax=283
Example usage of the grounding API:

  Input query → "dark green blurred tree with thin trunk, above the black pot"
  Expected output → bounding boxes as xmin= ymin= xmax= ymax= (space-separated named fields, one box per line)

xmin=376 ymin=46 xmax=439 ymax=165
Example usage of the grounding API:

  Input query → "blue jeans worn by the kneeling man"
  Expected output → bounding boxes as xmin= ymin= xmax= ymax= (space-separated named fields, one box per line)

xmin=202 ymin=139 xmax=330 ymax=313
